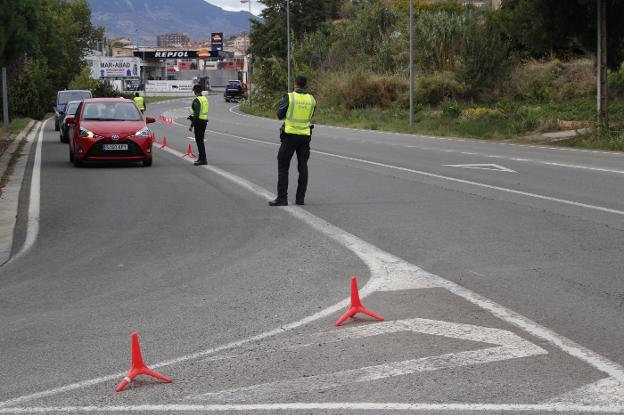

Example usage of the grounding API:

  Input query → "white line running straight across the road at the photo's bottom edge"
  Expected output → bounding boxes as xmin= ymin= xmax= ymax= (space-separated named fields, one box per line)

xmin=0 ymin=402 xmax=624 ymax=414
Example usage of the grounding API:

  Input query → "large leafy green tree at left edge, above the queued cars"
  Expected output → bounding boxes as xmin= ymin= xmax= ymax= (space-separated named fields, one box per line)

xmin=0 ymin=0 xmax=104 ymax=115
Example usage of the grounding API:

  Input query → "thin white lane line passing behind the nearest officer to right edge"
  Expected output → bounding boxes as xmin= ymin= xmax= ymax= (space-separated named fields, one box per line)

xmin=200 ymin=130 xmax=624 ymax=216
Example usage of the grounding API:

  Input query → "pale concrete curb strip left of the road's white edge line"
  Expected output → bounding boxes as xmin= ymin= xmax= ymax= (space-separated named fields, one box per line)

xmin=0 ymin=121 xmax=42 ymax=266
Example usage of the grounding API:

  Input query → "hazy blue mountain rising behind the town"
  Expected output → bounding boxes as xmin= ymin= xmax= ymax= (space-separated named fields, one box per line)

xmin=87 ymin=0 xmax=257 ymax=45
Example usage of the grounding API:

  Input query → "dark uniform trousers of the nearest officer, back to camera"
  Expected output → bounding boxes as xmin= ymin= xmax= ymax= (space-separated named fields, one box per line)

xmin=277 ymin=133 xmax=311 ymax=200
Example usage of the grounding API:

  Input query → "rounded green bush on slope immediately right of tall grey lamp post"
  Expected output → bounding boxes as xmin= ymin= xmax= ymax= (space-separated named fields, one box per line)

xmin=414 ymin=72 xmax=466 ymax=105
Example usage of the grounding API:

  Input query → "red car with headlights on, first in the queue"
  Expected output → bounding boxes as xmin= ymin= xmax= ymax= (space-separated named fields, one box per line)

xmin=65 ymin=98 xmax=156 ymax=167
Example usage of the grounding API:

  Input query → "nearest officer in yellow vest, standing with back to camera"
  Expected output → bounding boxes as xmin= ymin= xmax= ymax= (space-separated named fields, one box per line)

xmin=269 ymin=75 xmax=316 ymax=206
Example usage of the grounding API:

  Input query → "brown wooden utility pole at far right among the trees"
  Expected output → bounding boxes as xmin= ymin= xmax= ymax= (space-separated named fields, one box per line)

xmin=596 ymin=0 xmax=609 ymax=132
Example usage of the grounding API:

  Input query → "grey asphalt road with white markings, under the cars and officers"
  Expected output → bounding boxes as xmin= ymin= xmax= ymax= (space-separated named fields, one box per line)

xmin=0 ymin=96 xmax=624 ymax=414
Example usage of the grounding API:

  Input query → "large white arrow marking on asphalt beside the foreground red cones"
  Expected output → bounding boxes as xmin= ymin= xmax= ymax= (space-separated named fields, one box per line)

xmin=186 ymin=318 xmax=547 ymax=402
